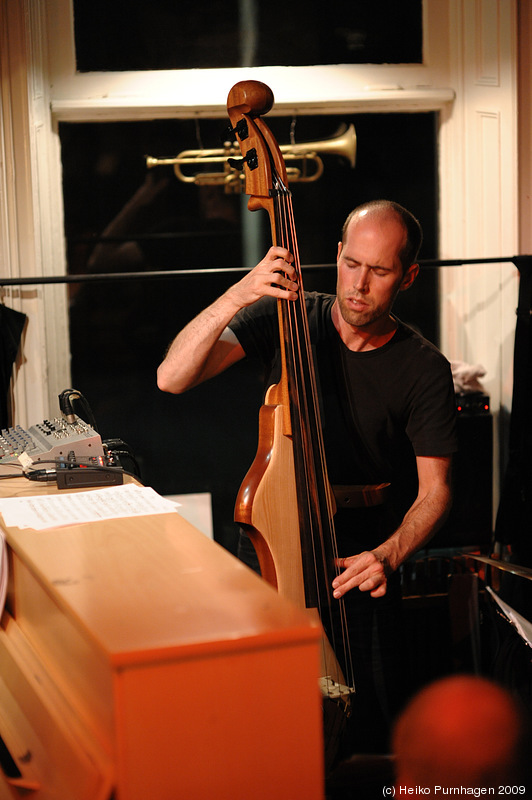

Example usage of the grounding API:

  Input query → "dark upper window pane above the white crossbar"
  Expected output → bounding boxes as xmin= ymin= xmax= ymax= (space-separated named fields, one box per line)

xmin=74 ymin=0 xmax=422 ymax=72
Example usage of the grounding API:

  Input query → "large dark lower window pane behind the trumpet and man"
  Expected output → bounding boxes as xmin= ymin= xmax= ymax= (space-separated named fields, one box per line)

xmin=59 ymin=114 xmax=437 ymax=549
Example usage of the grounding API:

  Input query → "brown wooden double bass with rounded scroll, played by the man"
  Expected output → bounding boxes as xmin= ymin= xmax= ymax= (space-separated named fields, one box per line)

xmin=227 ymin=80 xmax=355 ymax=765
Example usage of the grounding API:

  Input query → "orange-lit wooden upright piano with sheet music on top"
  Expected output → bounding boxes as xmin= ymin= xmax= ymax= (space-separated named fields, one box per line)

xmin=0 ymin=479 xmax=323 ymax=800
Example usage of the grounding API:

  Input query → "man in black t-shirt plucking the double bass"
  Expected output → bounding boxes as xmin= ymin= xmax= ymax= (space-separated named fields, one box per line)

xmin=158 ymin=200 xmax=456 ymax=752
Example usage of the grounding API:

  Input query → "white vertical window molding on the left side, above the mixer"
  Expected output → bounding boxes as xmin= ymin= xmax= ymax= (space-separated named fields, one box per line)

xmin=0 ymin=0 xmax=69 ymax=425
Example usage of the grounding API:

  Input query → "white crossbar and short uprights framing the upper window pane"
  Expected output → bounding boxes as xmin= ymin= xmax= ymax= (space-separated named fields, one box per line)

xmin=47 ymin=0 xmax=454 ymax=121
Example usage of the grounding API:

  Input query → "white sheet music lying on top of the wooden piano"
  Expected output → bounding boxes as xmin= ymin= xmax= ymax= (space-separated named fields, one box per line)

xmin=0 ymin=483 xmax=179 ymax=530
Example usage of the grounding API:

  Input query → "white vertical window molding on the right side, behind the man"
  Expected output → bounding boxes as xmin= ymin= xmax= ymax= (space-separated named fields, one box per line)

xmin=440 ymin=0 xmax=518 ymax=520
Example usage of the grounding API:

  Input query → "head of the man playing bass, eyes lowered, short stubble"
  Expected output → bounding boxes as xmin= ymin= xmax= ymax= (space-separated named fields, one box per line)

xmin=336 ymin=211 xmax=418 ymax=333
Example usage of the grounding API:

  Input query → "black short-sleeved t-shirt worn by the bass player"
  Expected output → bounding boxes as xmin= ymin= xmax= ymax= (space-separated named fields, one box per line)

xmin=230 ymin=292 xmax=456 ymax=544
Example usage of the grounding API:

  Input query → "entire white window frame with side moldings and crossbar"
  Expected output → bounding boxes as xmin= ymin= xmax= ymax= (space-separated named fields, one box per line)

xmin=0 ymin=0 xmax=518 ymax=520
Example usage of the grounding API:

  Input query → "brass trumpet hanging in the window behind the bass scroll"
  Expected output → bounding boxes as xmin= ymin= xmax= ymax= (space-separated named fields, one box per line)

xmin=146 ymin=123 xmax=357 ymax=193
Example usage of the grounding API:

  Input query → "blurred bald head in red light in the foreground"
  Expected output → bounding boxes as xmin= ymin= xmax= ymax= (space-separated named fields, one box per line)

xmin=393 ymin=675 xmax=524 ymax=787
